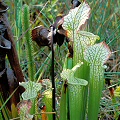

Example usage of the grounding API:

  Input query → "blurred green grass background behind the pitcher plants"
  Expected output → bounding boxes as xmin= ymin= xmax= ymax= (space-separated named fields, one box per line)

xmin=0 ymin=0 xmax=120 ymax=120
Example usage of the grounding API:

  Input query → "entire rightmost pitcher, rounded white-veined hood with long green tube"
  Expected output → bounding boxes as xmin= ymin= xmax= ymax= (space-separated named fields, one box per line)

xmin=84 ymin=42 xmax=111 ymax=120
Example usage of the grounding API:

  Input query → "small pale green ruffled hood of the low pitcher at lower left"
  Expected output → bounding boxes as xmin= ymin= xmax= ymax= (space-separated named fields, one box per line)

xmin=19 ymin=81 xmax=42 ymax=100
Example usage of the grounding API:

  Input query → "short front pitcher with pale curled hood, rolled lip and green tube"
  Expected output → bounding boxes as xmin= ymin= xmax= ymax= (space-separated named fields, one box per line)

xmin=60 ymin=63 xmax=88 ymax=120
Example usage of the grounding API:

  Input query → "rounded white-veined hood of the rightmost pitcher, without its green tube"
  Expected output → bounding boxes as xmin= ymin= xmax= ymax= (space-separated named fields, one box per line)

xmin=84 ymin=42 xmax=111 ymax=65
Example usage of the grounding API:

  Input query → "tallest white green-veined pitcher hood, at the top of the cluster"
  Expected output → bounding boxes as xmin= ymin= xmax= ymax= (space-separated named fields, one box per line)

xmin=62 ymin=2 xmax=90 ymax=35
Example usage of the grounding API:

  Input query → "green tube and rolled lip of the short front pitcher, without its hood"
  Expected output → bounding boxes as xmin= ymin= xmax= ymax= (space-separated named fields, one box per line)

xmin=68 ymin=79 xmax=88 ymax=120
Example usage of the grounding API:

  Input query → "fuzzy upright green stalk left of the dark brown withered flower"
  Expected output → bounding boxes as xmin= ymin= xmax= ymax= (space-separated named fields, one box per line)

xmin=23 ymin=4 xmax=34 ymax=81
